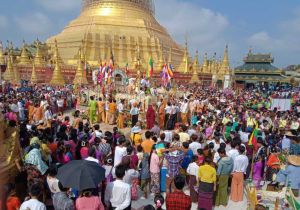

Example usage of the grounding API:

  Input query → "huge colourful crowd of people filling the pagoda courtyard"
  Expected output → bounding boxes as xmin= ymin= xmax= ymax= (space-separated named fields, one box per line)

xmin=0 ymin=83 xmax=300 ymax=210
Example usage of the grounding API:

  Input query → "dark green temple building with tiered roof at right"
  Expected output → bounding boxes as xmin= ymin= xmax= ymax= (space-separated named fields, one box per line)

xmin=234 ymin=49 xmax=290 ymax=87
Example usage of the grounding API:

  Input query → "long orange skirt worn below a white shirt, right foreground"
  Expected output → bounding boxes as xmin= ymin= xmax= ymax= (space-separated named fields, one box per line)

xmin=230 ymin=172 xmax=244 ymax=202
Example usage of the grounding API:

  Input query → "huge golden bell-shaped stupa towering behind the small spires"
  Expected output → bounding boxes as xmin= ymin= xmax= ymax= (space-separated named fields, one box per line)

xmin=47 ymin=0 xmax=184 ymax=70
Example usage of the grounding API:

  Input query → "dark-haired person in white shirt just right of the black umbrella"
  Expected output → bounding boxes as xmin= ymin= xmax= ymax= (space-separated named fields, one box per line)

xmin=104 ymin=165 xmax=131 ymax=210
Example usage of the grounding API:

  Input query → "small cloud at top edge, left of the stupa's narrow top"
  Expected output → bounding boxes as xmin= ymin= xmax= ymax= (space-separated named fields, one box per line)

xmin=34 ymin=0 xmax=81 ymax=12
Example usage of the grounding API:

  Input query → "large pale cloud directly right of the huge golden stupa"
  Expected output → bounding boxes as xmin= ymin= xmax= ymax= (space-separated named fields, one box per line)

xmin=156 ymin=0 xmax=230 ymax=54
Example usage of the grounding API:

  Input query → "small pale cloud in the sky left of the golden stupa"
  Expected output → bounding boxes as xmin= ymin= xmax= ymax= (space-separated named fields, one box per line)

xmin=14 ymin=12 xmax=53 ymax=36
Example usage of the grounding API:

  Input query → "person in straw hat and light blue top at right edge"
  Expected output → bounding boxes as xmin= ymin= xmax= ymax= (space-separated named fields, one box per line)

xmin=276 ymin=155 xmax=300 ymax=197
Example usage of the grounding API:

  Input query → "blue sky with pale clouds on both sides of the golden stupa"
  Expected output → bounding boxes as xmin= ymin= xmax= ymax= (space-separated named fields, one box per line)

xmin=0 ymin=0 xmax=300 ymax=67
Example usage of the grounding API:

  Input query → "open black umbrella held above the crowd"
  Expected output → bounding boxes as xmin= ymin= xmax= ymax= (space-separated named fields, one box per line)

xmin=57 ymin=160 xmax=105 ymax=191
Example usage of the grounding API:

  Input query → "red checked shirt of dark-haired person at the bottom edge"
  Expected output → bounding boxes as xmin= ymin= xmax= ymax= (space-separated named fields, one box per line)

xmin=166 ymin=190 xmax=192 ymax=210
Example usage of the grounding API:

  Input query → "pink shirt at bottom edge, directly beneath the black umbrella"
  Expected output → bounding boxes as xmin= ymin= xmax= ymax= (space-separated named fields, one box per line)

xmin=75 ymin=196 xmax=104 ymax=210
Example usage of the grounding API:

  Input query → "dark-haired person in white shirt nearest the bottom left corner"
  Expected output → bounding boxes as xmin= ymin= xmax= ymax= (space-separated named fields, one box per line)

xmin=20 ymin=184 xmax=46 ymax=210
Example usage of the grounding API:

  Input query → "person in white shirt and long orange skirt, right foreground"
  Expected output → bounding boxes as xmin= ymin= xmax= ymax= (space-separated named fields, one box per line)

xmin=230 ymin=146 xmax=249 ymax=202
